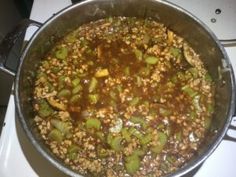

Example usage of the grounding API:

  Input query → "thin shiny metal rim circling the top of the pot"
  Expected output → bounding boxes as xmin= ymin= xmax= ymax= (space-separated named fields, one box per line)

xmin=14 ymin=0 xmax=235 ymax=177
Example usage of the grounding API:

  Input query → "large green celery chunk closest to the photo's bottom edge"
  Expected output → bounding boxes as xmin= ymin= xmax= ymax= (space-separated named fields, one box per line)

xmin=125 ymin=155 xmax=140 ymax=175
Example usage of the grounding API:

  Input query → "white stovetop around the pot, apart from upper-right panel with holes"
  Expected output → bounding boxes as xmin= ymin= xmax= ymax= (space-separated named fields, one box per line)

xmin=0 ymin=0 xmax=236 ymax=177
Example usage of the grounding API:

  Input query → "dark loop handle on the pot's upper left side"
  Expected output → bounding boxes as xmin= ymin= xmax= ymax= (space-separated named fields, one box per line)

xmin=0 ymin=19 xmax=42 ymax=76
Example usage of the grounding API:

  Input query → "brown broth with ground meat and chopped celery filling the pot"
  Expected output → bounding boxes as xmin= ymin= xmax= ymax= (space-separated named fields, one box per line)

xmin=34 ymin=17 xmax=214 ymax=177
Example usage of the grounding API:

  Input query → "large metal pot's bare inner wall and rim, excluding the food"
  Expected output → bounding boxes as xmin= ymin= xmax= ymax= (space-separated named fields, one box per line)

xmin=1 ymin=0 xmax=235 ymax=176
